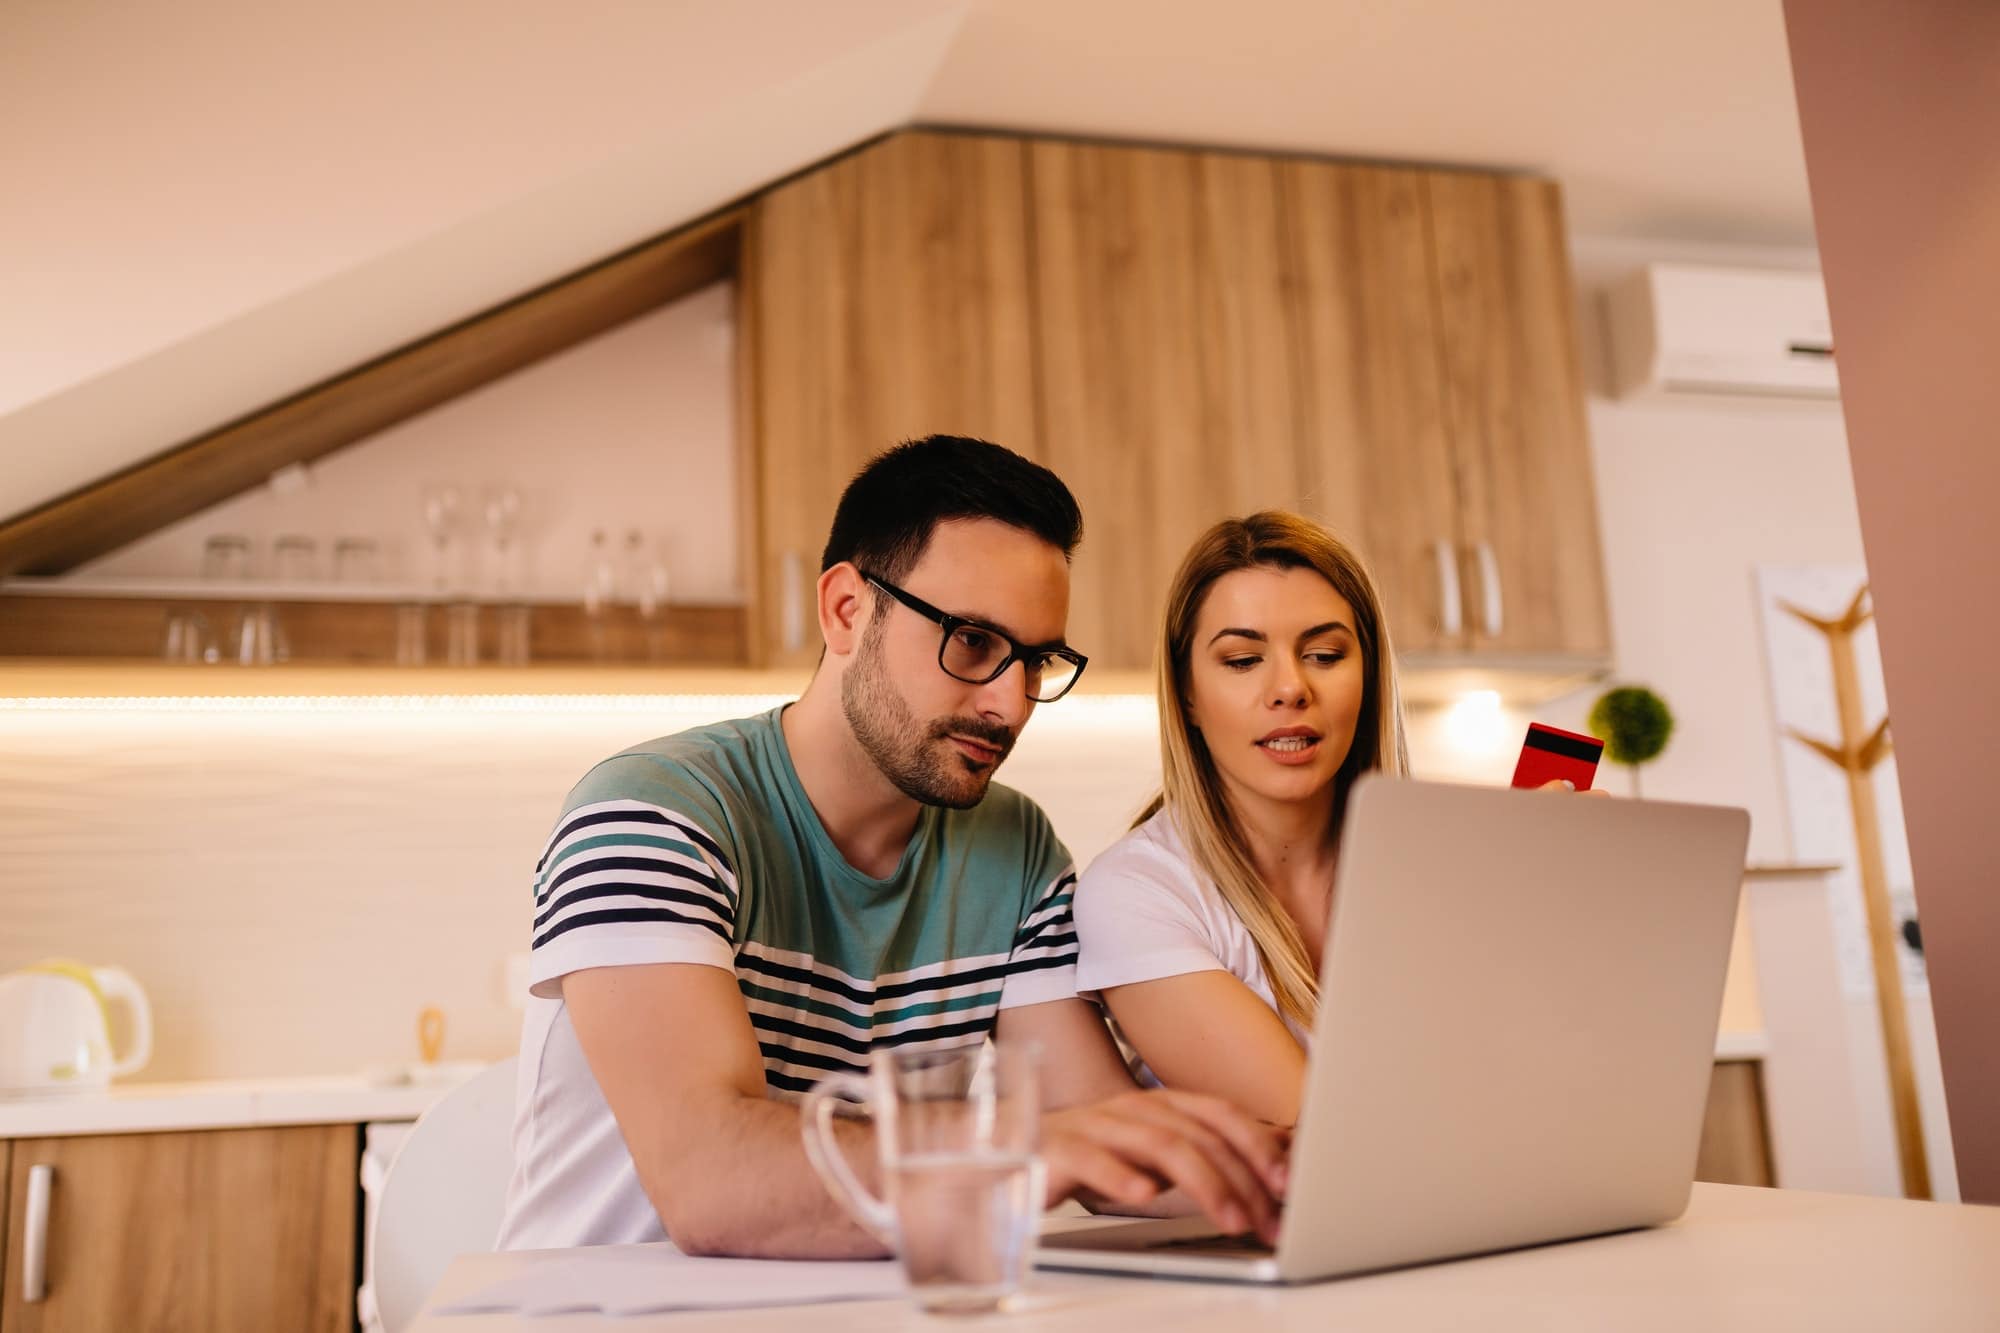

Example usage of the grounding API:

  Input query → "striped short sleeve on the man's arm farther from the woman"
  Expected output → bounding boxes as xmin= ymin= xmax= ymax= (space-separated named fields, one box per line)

xmin=528 ymin=755 xmax=738 ymax=999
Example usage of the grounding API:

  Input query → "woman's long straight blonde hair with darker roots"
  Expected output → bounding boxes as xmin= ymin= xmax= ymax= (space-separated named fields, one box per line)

xmin=1134 ymin=510 xmax=1410 ymax=1029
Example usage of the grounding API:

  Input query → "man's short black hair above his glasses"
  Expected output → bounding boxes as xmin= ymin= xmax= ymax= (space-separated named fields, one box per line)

xmin=820 ymin=434 xmax=1084 ymax=582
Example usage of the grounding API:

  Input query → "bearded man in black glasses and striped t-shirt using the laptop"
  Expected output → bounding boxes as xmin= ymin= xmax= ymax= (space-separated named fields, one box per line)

xmin=500 ymin=436 xmax=1284 ymax=1257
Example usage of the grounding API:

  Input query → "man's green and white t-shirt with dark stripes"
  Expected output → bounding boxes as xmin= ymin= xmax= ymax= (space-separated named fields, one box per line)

xmin=500 ymin=711 xmax=1076 ymax=1249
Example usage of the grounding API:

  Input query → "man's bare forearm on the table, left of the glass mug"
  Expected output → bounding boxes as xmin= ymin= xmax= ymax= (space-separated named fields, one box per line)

xmin=634 ymin=1097 xmax=888 ymax=1259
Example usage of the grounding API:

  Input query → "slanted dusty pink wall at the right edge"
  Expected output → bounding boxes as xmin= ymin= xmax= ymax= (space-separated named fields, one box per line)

xmin=1784 ymin=0 xmax=2000 ymax=1203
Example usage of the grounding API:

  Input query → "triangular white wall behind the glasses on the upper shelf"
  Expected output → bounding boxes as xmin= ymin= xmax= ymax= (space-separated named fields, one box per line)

xmin=82 ymin=282 xmax=744 ymax=602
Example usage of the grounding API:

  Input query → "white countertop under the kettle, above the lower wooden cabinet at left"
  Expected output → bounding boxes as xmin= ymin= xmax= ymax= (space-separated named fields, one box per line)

xmin=0 ymin=1065 xmax=480 ymax=1139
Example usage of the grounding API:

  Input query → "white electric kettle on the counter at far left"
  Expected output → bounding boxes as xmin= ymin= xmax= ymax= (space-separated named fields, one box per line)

xmin=0 ymin=959 xmax=152 ymax=1097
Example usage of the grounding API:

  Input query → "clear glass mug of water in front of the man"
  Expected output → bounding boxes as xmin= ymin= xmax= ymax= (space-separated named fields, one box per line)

xmin=800 ymin=1043 xmax=1044 ymax=1315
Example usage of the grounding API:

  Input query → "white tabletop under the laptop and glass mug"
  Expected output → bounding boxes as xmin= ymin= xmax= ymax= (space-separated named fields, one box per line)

xmin=410 ymin=1185 xmax=2000 ymax=1333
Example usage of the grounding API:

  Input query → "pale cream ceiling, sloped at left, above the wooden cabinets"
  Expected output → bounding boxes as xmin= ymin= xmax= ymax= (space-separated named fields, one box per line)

xmin=0 ymin=0 xmax=1812 ymax=516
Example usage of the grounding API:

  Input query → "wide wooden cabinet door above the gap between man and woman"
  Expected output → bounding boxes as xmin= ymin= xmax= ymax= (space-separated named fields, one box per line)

xmin=1028 ymin=140 xmax=1308 ymax=669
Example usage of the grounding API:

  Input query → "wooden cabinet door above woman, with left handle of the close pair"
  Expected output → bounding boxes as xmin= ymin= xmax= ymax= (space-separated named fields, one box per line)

xmin=1278 ymin=162 xmax=1464 ymax=654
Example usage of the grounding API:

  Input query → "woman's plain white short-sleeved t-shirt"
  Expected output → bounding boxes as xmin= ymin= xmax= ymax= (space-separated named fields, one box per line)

xmin=1072 ymin=811 xmax=1308 ymax=1087
